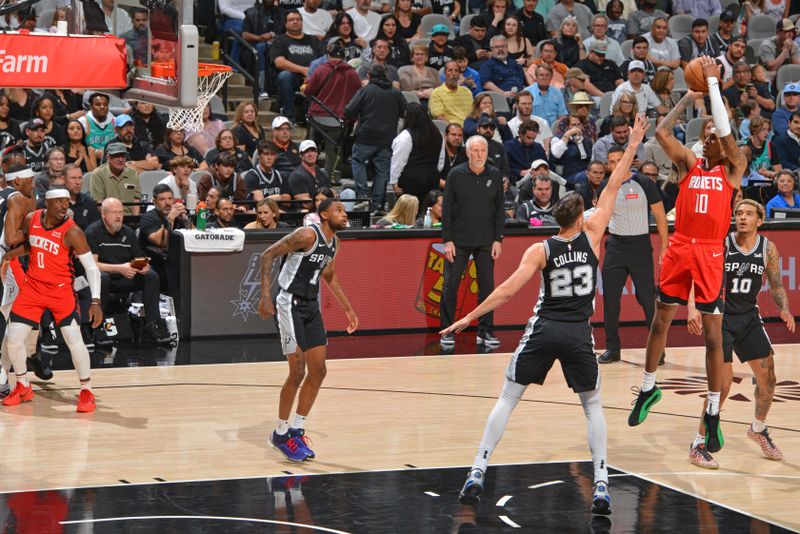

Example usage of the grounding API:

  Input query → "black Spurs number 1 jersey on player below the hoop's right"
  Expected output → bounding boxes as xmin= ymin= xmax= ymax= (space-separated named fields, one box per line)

xmin=278 ymin=224 xmax=339 ymax=300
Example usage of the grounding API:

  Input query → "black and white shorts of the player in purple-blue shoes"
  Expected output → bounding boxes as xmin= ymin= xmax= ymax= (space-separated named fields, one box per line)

xmin=275 ymin=291 xmax=328 ymax=354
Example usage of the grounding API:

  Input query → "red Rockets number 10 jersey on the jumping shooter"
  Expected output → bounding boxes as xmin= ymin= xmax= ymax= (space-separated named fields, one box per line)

xmin=675 ymin=158 xmax=734 ymax=243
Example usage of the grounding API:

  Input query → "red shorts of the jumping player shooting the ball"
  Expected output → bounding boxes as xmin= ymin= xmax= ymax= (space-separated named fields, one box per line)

xmin=657 ymin=233 xmax=725 ymax=314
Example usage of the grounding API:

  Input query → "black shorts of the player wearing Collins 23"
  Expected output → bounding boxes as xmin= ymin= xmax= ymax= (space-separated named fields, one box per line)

xmin=506 ymin=317 xmax=598 ymax=393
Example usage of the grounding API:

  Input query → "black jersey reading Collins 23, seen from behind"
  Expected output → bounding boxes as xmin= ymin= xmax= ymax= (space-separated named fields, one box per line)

xmin=534 ymin=232 xmax=600 ymax=322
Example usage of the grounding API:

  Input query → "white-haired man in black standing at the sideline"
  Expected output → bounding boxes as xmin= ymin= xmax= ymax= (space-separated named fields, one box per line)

xmin=440 ymin=136 xmax=505 ymax=348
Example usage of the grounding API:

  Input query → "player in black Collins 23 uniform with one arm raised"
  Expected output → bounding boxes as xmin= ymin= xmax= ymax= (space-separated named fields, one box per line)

xmin=441 ymin=115 xmax=648 ymax=515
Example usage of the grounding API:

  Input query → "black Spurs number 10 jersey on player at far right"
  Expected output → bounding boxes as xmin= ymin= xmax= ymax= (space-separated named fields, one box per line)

xmin=725 ymin=232 xmax=769 ymax=315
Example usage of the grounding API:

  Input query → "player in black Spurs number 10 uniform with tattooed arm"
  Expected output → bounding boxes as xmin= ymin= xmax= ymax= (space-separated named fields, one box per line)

xmin=688 ymin=200 xmax=794 ymax=469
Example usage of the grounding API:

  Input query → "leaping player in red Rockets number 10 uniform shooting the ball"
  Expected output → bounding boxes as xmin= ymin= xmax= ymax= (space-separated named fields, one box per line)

xmin=628 ymin=56 xmax=747 ymax=452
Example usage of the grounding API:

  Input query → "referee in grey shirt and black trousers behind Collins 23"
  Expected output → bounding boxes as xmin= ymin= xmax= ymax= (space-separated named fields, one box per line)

xmin=597 ymin=164 xmax=669 ymax=363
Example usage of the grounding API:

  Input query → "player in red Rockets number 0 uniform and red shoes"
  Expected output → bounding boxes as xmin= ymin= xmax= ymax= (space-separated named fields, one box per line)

xmin=3 ymin=189 xmax=103 ymax=412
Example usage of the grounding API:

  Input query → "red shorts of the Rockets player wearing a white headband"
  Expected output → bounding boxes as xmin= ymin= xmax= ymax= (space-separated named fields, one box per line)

xmin=11 ymin=278 xmax=81 ymax=326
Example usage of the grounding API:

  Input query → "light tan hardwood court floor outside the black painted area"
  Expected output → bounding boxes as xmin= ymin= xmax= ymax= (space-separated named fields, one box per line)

xmin=0 ymin=345 xmax=800 ymax=530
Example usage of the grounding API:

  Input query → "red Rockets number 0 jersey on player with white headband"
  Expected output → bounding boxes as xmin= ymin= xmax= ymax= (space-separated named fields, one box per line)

xmin=27 ymin=209 xmax=75 ymax=287
